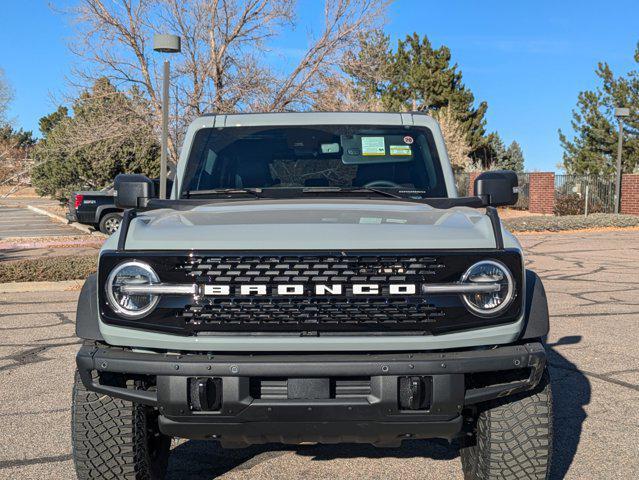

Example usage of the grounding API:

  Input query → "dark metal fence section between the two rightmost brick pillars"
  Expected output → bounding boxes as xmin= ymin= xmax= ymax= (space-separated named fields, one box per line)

xmin=555 ymin=175 xmax=615 ymax=215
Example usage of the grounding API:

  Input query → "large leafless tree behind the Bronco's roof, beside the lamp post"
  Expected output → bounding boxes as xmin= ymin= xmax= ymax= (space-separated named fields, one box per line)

xmin=63 ymin=0 xmax=387 ymax=163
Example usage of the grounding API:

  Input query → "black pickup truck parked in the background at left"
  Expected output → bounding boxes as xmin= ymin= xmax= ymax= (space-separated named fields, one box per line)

xmin=67 ymin=179 xmax=172 ymax=235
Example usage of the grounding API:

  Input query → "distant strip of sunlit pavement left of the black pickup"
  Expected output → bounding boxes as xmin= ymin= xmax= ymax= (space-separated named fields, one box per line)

xmin=0 ymin=205 xmax=82 ymax=240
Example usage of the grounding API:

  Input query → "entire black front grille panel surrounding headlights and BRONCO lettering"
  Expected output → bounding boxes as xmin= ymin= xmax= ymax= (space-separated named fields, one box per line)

xmin=98 ymin=250 xmax=523 ymax=336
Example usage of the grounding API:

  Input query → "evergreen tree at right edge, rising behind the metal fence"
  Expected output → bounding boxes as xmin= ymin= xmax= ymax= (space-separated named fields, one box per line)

xmin=559 ymin=43 xmax=639 ymax=174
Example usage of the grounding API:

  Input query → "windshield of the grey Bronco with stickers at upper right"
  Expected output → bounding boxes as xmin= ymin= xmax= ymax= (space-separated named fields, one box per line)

xmin=181 ymin=125 xmax=447 ymax=198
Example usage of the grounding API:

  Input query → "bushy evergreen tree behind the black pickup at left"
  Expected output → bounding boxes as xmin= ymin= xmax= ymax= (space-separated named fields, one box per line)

xmin=32 ymin=78 xmax=160 ymax=198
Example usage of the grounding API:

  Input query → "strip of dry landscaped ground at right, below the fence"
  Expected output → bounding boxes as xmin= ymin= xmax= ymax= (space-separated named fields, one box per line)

xmin=502 ymin=213 xmax=639 ymax=232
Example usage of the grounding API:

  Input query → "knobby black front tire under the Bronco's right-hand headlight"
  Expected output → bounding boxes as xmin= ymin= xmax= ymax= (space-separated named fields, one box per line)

xmin=461 ymin=369 xmax=553 ymax=480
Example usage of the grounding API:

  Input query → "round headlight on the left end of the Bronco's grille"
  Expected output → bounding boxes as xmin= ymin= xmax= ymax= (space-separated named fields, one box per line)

xmin=106 ymin=261 xmax=160 ymax=318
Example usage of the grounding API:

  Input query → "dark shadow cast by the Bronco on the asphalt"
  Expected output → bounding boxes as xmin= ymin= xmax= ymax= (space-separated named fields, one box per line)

xmin=167 ymin=336 xmax=591 ymax=480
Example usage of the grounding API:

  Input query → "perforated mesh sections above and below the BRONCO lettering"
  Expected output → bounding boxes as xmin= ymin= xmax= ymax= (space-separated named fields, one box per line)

xmin=180 ymin=255 xmax=446 ymax=331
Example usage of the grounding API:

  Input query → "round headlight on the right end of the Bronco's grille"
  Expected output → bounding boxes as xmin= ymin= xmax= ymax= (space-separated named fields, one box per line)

xmin=461 ymin=260 xmax=515 ymax=316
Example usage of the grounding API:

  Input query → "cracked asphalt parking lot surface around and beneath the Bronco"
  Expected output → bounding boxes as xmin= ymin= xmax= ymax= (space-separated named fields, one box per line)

xmin=0 ymin=231 xmax=639 ymax=480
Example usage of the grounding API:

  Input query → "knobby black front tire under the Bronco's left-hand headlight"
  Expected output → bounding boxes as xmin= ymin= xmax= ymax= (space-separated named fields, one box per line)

xmin=71 ymin=371 xmax=171 ymax=480
